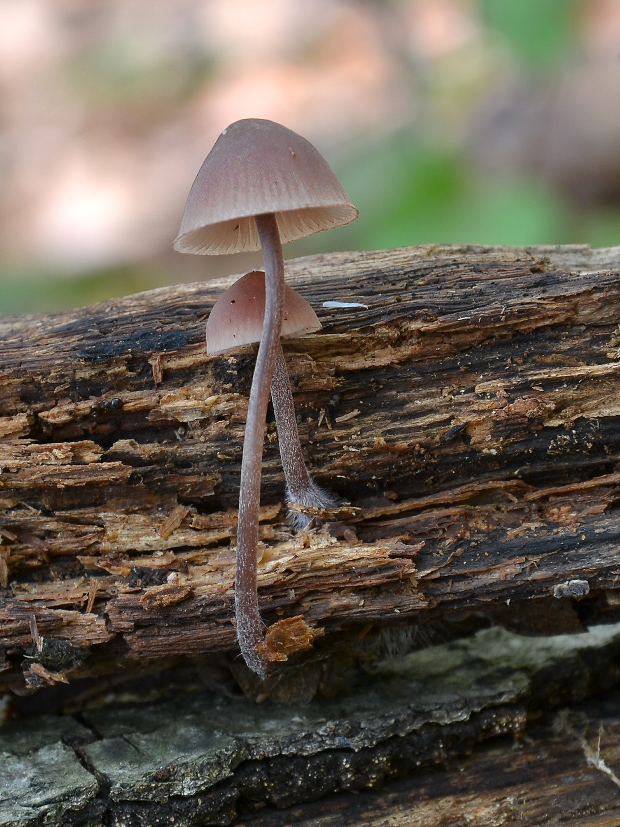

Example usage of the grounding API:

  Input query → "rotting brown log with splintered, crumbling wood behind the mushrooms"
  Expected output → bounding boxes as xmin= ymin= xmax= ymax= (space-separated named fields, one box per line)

xmin=0 ymin=246 xmax=620 ymax=691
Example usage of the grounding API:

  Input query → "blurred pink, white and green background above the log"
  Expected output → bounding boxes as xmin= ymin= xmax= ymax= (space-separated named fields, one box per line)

xmin=0 ymin=0 xmax=620 ymax=313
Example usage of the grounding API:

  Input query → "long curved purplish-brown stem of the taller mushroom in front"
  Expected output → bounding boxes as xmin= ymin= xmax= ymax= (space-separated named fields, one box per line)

xmin=235 ymin=213 xmax=284 ymax=678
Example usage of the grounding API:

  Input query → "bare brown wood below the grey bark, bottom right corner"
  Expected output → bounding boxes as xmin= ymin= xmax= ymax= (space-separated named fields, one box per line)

xmin=235 ymin=693 xmax=620 ymax=827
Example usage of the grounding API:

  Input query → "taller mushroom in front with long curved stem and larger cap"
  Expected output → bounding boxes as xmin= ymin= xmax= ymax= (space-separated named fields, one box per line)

xmin=174 ymin=118 xmax=357 ymax=677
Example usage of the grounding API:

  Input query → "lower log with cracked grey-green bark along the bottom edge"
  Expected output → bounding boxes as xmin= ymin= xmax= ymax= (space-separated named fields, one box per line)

xmin=0 ymin=625 xmax=620 ymax=827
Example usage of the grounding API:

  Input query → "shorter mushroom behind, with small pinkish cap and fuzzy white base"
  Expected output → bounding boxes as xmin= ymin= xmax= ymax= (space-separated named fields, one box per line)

xmin=207 ymin=270 xmax=337 ymax=528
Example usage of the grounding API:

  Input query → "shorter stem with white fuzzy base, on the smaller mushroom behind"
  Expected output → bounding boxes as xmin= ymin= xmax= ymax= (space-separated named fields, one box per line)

xmin=271 ymin=342 xmax=337 ymax=528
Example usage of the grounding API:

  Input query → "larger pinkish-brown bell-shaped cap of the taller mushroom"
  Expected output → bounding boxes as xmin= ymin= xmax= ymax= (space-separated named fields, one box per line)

xmin=174 ymin=118 xmax=358 ymax=255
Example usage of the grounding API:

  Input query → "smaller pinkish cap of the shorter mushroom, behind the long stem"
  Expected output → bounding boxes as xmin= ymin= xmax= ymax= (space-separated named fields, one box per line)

xmin=207 ymin=270 xmax=322 ymax=356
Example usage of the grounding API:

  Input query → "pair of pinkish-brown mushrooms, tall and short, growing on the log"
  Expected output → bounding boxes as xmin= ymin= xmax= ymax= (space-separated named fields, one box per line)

xmin=174 ymin=118 xmax=357 ymax=677
